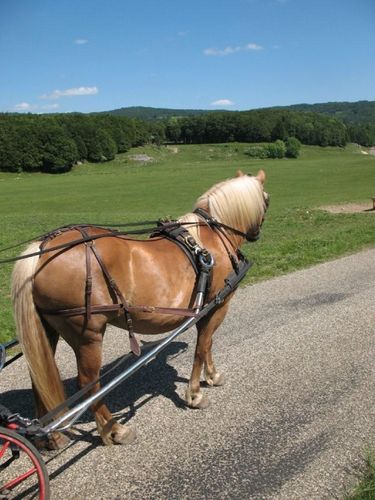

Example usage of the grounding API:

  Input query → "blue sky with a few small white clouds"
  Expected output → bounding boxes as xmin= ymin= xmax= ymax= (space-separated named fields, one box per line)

xmin=0 ymin=0 xmax=375 ymax=113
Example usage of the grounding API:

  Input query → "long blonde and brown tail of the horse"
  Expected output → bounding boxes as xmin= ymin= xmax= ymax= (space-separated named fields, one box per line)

xmin=12 ymin=241 xmax=65 ymax=411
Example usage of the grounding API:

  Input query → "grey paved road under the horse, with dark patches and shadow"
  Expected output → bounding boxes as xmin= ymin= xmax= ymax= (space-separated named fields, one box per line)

xmin=0 ymin=249 xmax=375 ymax=500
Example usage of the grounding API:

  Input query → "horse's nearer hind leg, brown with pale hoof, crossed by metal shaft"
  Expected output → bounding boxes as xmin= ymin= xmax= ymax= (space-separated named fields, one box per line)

xmin=75 ymin=330 xmax=136 ymax=445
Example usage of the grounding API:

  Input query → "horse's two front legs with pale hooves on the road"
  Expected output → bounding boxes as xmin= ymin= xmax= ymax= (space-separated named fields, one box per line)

xmin=185 ymin=303 xmax=229 ymax=409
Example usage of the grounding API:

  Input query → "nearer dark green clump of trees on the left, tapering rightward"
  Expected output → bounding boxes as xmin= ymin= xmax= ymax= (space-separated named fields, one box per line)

xmin=0 ymin=113 xmax=163 ymax=173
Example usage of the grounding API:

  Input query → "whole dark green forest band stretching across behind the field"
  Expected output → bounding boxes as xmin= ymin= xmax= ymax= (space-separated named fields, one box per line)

xmin=0 ymin=104 xmax=375 ymax=173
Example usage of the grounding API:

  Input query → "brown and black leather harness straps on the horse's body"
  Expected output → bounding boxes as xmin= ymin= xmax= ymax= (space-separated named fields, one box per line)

xmin=4 ymin=208 xmax=255 ymax=356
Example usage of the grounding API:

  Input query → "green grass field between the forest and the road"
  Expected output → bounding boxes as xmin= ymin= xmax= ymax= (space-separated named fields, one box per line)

xmin=0 ymin=144 xmax=375 ymax=340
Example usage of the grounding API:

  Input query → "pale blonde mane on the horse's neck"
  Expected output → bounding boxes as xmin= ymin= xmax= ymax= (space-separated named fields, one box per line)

xmin=179 ymin=175 xmax=265 ymax=247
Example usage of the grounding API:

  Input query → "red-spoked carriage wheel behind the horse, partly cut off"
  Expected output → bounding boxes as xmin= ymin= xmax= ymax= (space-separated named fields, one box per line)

xmin=0 ymin=427 xmax=50 ymax=500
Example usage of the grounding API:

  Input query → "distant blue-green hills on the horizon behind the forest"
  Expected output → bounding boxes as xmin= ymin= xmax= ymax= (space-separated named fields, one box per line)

xmin=107 ymin=101 xmax=375 ymax=124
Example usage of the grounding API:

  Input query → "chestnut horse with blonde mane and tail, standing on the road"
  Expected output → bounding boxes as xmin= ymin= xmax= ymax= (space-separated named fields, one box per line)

xmin=12 ymin=170 xmax=268 ymax=449
